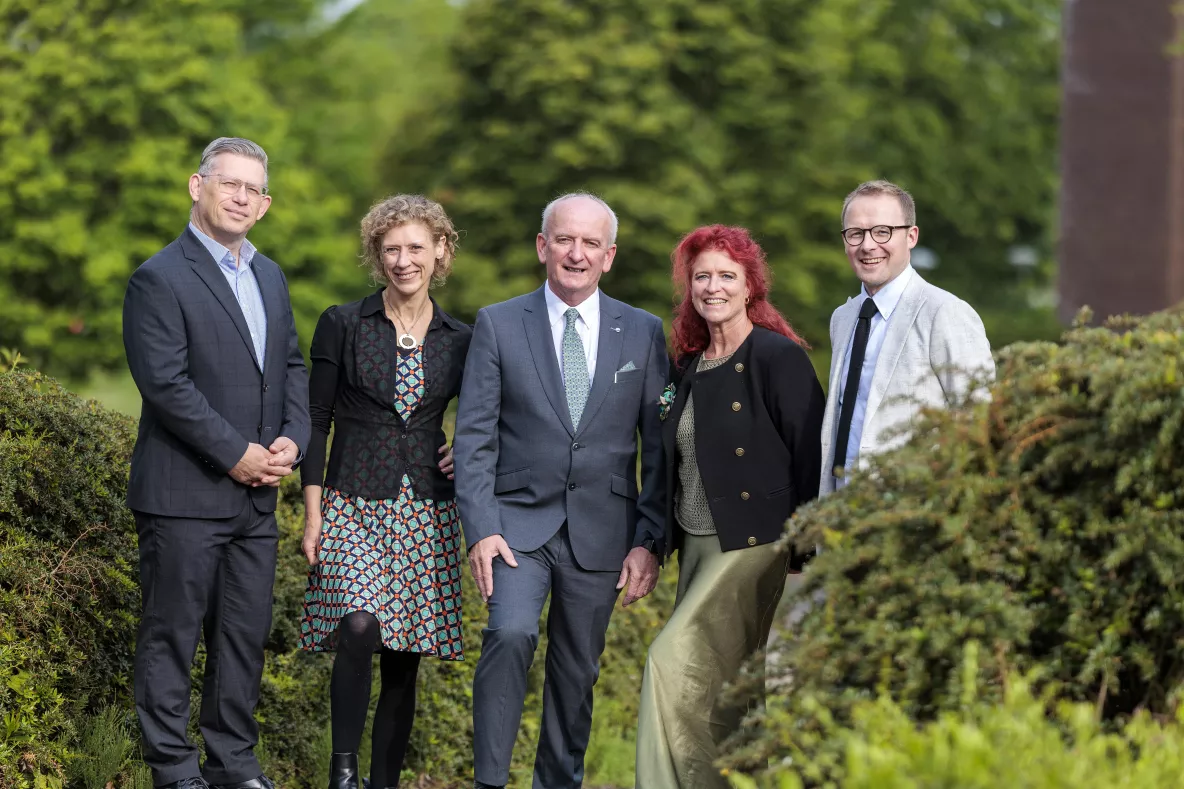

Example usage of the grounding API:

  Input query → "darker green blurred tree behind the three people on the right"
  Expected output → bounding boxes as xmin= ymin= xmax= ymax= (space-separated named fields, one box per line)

xmin=387 ymin=0 xmax=1060 ymax=345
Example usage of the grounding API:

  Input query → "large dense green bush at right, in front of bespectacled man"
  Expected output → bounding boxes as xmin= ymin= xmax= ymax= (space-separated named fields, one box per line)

xmin=729 ymin=312 xmax=1184 ymax=781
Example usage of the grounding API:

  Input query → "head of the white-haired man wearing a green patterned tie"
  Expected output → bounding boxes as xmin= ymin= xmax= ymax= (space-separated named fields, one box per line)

xmin=535 ymin=198 xmax=617 ymax=307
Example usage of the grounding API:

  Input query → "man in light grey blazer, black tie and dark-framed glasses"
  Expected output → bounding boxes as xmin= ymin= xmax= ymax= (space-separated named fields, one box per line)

xmin=819 ymin=181 xmax=995 ymax=495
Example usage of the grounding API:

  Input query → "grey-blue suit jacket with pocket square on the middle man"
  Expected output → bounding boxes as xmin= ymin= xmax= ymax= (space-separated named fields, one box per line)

xmin=453 ymin=288 xmax=669 ymax=571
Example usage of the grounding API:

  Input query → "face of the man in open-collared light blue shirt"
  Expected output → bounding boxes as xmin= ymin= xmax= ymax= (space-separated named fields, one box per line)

xmin=189 ymin=153 xmax=271 ymax=242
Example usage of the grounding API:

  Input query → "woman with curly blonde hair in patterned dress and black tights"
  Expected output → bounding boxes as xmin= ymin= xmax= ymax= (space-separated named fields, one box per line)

xmin=301 ymin=194 xmax=472 ymax=789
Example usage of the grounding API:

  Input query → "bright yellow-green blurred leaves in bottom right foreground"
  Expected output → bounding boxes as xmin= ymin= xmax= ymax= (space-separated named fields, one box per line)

xmin=731 ymin=649 xmax=1184 ymax=789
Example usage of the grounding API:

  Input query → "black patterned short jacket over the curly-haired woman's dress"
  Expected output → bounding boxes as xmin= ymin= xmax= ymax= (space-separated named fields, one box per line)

xmin=301 ymin=289 xmax=472 ymax=499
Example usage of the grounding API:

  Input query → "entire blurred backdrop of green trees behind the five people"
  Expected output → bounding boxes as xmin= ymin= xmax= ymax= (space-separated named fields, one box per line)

xmin=0 ymin=0 xmax=1060 ymax=380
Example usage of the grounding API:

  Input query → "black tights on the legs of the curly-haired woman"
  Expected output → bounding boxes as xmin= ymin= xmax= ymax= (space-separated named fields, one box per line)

xmin=329 ymin=611 xmax=419 ymax=789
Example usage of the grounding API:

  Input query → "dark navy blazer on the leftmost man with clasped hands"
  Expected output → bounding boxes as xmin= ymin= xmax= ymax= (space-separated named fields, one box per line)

xmin=123 ymin=227 xmax=309 ymax=518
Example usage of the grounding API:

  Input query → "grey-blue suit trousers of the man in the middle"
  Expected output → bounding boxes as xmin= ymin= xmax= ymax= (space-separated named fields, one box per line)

xmin=472 ymin=525 xmax=620 ymax=789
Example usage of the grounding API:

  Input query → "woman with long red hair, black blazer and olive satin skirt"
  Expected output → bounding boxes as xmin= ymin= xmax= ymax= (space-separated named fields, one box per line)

xmin=637 ymin=225 xmax=825 ymax=789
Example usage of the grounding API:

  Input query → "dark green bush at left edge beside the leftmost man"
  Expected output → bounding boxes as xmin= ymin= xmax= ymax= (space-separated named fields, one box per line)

xmin=0 ymin=370 xmax=139 ymax=787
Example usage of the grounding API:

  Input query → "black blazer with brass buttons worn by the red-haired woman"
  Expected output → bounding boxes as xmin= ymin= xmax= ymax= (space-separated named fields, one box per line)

xmin=662 ymin=326 xmax=826 ymax=551
